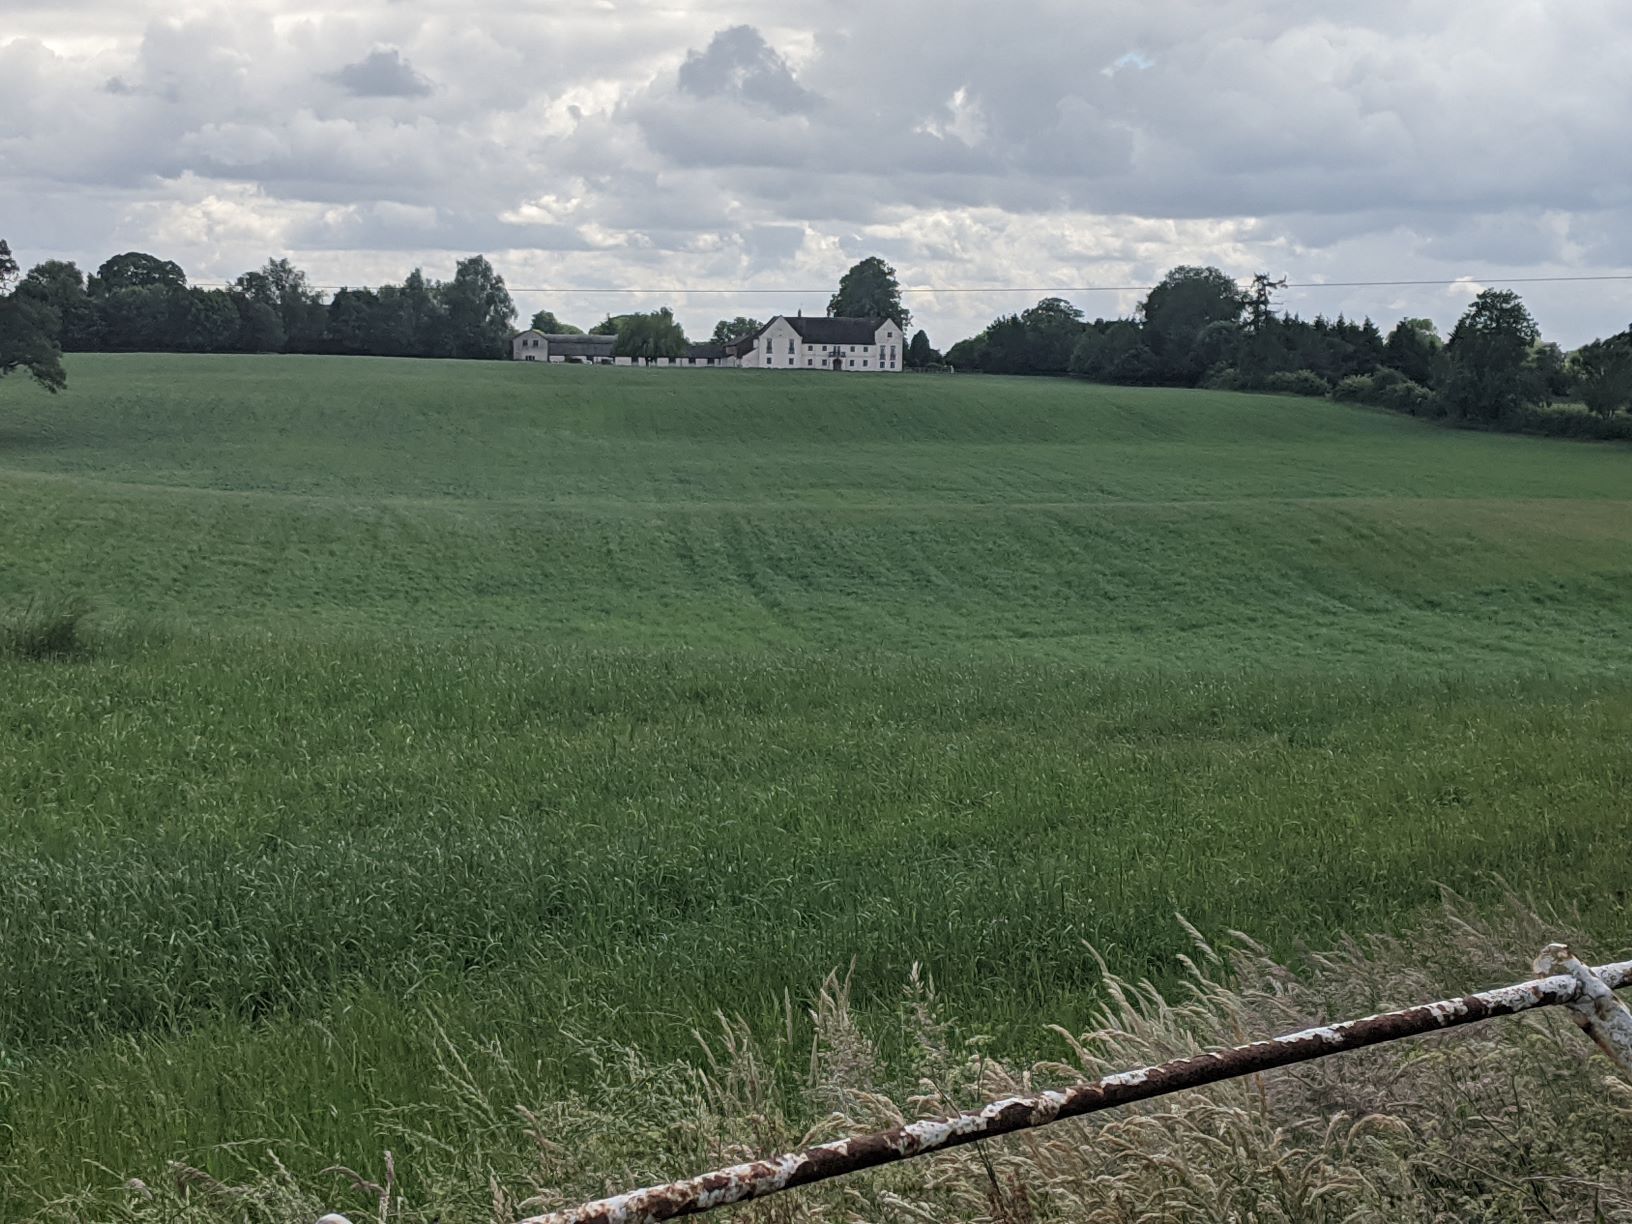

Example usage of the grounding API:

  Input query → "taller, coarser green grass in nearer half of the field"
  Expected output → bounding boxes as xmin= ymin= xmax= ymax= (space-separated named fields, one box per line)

xmin=9 ymin=638 xmax=1632 ymax=1214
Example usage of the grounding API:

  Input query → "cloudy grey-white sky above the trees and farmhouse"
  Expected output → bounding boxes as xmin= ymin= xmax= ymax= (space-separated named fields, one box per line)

xmin=0 ymin=0 xmax=1632 ymax=346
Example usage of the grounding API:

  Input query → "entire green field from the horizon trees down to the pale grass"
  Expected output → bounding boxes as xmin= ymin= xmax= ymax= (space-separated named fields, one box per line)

xmin=0 ymin=356 xmax=1632 ymax=1219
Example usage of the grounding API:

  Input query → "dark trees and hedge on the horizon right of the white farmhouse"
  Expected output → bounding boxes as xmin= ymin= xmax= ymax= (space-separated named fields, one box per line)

xmin=947 ymin=266 xmax=1632 ymax=439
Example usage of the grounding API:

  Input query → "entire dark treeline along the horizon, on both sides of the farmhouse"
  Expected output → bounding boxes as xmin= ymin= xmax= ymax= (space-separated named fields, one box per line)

xmin=0 ymin=243 xmax=1632 ymax=439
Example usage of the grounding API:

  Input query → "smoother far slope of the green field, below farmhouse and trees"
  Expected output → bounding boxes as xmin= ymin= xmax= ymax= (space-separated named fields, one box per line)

xmin=0 ymin=357 xmax=1632 ymax=671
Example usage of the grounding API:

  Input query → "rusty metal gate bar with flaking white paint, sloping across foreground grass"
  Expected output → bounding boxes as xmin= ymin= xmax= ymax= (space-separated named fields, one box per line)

xmin=521 ymin=945 xmax=1632 ymax=1224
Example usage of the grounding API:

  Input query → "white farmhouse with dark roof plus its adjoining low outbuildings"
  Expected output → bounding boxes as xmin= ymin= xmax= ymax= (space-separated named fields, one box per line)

xmin=511 ymin=315 xmax=906 ymax=374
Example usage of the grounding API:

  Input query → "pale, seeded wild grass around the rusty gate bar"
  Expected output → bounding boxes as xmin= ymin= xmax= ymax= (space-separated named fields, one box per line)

xmin=19 ymin=902 xmax=1632 ymax=1224
